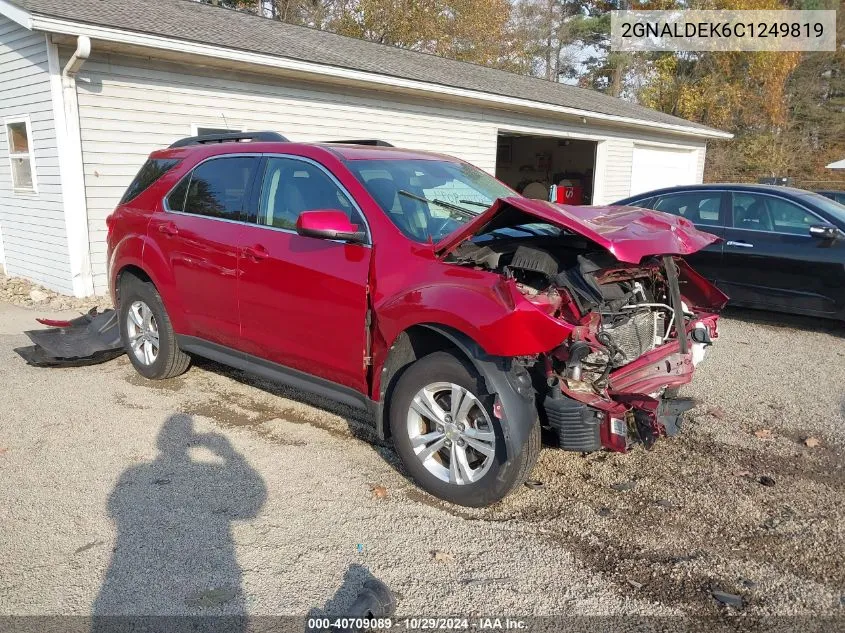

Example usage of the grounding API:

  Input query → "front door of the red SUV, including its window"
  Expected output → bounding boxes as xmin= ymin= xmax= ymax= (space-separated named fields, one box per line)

xmin=239 ymin=156 xmax=371 ymax=393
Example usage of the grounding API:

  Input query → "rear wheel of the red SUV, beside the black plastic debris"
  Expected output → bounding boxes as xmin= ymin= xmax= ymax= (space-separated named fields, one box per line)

xmin=119 ymin=274 xmax=191 ymax=380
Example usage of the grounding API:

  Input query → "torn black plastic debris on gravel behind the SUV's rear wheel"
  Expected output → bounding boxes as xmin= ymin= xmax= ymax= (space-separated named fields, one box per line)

xmin=15 ymin=308 xmax=123 ymax=367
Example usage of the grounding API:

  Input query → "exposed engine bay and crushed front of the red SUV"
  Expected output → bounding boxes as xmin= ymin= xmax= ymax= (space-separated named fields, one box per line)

xmin=438 ymin=198 xmax=727 ymax=452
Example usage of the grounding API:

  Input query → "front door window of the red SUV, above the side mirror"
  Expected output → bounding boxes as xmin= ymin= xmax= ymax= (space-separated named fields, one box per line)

xmin=258 ymin=157 xmax=364 ymax=230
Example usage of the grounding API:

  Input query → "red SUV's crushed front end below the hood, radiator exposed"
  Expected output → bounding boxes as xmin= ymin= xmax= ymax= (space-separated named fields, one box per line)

xmin=538 ymin=256 xmax=718 ymax=452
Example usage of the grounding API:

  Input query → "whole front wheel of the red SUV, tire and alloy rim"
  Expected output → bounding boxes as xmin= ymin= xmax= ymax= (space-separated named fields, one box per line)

xmin=390 ymin=352 xmax=540 ymax=507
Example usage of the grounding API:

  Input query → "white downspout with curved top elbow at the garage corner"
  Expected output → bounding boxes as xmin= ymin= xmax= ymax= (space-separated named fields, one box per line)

xmin=53 ymin=35 xmax=94 ymax=297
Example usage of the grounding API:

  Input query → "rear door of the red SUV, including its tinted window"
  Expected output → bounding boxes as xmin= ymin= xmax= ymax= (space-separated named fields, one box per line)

xmin=148 ymin=156 xmax=260 ymax=347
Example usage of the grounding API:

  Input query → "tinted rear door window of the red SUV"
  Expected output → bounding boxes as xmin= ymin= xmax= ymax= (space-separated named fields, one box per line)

xmin=177 ymin=156 xmax=258 ymax=220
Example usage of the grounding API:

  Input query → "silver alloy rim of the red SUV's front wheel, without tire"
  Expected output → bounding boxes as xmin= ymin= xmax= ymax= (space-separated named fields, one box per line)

xmin=407 ymin=382 xmax=496 ymax=485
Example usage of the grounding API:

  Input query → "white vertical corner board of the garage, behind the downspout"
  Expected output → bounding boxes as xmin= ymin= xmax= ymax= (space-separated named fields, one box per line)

xmin=45 ymin=35 xmax=94 ymax=297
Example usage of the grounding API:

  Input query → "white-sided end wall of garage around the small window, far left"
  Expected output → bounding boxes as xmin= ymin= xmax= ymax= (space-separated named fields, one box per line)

xmin=0 ymin=16 xmax=73 ymax=294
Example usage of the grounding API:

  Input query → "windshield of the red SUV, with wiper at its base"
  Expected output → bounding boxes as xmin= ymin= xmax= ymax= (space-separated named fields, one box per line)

xmin=347 ymin=159 xmax=518 ymax=242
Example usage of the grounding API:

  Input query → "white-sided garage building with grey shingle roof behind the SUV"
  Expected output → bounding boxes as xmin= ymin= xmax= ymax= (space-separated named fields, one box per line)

xmin=0 ymin=0 xmax=729 ymax=295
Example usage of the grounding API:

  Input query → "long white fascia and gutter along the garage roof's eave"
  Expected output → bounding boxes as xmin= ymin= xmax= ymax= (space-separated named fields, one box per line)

xmin=26 ymin=14 xmax=733 ymax=138
